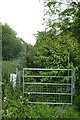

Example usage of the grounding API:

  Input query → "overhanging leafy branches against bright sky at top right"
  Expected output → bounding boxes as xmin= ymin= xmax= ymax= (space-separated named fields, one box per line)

xmin=44 ymin=0 xmax=80 ymax=42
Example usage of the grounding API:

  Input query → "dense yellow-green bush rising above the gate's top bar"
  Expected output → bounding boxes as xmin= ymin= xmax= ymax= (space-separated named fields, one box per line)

xmin=34 ymin=31 xmax=79 ymax=68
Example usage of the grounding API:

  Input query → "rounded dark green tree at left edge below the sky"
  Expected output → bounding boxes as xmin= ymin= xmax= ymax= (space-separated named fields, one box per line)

xmin=2 ymin=24 xmax=23 ymax=60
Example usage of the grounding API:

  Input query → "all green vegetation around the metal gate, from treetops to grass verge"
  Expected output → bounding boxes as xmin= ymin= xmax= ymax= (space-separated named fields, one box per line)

xmin=2 ymin=0 xmax=80 ymax=119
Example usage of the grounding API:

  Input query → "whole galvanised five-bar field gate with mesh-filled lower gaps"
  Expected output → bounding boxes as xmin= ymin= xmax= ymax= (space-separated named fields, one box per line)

xmin=23 ymin=68 xmax=75 ymax=105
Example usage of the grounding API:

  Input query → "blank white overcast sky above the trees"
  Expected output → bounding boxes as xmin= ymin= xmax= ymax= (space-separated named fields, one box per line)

xmin=0 ymin=0 xmax=45 ymax=45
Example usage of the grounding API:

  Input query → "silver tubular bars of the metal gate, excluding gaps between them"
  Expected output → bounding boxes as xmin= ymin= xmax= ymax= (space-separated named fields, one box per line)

xmin=23 ymin=68 xmax=75 ymax=105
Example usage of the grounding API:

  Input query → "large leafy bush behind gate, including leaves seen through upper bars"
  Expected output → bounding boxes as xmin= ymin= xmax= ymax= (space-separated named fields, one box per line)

xmin=34 ymin=30 xmax=80 ymax=96
